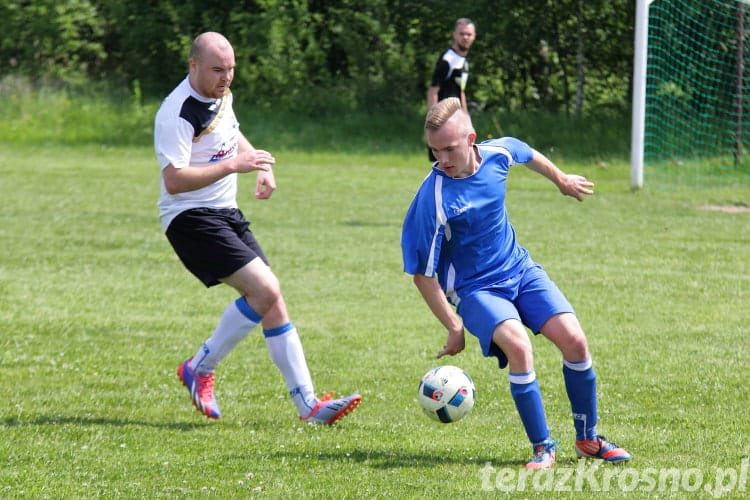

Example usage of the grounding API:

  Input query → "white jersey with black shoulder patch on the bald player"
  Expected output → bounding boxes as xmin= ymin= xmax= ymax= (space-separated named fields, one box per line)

xmin=154 ymin=77 xmax=240 ymax=231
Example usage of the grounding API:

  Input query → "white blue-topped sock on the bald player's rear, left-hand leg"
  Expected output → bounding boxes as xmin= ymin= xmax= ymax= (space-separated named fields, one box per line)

xmin=190 ymin=297 xmax=261 ymax=373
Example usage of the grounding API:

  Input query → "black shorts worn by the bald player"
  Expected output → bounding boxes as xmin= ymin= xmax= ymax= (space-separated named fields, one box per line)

xmin=166 ymin=208 xmax=268 ymax=287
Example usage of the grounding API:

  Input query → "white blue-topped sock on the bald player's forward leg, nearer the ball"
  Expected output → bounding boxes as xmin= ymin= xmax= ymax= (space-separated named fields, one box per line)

xmin=263 ymin=323 xmax=317 ymax=417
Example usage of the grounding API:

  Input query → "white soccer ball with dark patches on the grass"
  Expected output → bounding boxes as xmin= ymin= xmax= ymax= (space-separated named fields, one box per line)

xmin=417 ymin=365 xmax=476 ymax=424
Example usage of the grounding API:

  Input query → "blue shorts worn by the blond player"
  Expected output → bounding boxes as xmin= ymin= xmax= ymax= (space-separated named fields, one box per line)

xmin=456 ymin=263 xmax=575 ymax=368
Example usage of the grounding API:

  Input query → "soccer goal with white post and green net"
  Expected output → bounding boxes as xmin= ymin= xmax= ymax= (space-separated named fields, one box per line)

xmin=631 ymin=0 xmax=750 ymax=187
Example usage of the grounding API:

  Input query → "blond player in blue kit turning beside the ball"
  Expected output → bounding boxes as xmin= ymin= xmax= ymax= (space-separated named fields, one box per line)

xmin=401 ymin=98 xmax=630 ymax=469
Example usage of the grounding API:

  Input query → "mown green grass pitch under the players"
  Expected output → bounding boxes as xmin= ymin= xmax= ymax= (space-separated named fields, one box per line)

xmin=0 ymin=131 xmax=750 ymax=498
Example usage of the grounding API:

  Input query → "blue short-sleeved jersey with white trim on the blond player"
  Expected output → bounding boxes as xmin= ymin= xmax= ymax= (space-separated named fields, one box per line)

xmin=401 ymin=137 xmax=532 ymax=305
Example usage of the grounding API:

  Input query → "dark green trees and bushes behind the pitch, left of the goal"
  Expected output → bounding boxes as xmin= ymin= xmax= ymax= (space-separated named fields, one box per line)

xmin=0 ymin=0 xmax=634 ymax=116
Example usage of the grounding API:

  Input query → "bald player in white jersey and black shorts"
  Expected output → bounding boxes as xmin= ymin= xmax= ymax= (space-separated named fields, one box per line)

xmin=154 ymin=32 xmax=362 ymax=424
